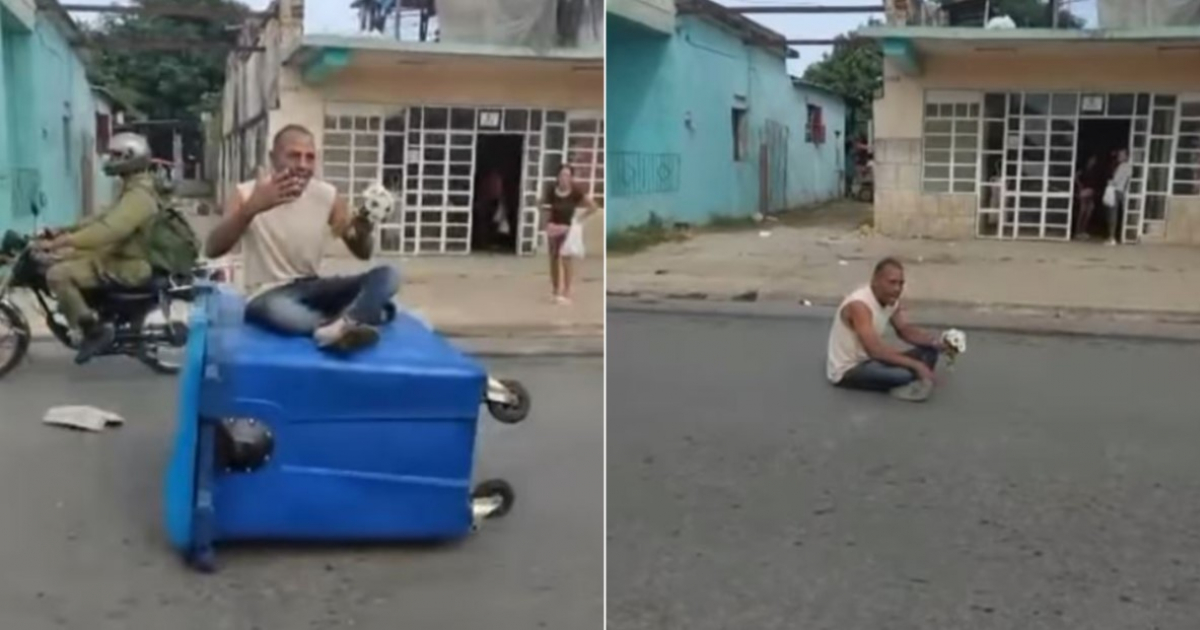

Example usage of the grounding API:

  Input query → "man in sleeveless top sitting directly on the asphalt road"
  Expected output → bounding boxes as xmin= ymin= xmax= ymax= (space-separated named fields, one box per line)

xmin=826 ymin=258 xmax=944 ymax=402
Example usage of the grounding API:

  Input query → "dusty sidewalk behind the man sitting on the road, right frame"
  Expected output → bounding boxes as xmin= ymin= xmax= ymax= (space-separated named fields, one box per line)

xmin=608 ymin=202 xmax=1200 ymax=324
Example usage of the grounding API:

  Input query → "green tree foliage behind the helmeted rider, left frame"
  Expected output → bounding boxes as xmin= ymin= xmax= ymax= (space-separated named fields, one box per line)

xmin=90 ymin=0 xmax=250 ymax=121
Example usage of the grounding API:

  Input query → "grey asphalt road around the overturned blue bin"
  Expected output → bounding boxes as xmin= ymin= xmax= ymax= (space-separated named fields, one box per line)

xmin=0 ymin=343 xmax=604 ymax=630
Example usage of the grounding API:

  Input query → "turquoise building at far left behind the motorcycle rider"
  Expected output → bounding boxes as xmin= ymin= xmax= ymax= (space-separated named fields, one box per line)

xmin=0 ymin=0 xmax=113 ymax=232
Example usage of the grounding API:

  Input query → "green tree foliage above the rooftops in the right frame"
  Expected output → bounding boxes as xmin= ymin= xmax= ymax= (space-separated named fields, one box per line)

xmin=804 ymin=0 xmax=1084 ymax=136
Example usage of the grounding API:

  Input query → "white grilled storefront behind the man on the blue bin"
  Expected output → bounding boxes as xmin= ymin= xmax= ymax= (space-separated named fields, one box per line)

xmin=322 ymin=103 xmax=604 ymax=254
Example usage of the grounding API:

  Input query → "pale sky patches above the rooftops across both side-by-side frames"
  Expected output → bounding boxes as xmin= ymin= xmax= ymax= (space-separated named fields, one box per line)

xmin=63 ymin=0 xmax=1096 ymax=74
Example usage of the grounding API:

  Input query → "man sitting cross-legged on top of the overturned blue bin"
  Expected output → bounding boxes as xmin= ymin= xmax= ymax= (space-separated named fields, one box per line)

xmin=206 ymin=125 xmax=400 ymax=352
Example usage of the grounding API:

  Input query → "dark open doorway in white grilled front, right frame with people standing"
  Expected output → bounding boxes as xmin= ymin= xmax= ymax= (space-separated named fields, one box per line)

xmin=1074 ymin=118 xmax=1133 ymax=238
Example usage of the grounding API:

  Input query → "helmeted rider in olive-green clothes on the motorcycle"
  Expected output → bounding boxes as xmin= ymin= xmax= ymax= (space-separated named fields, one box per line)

xmin=37 ymin=132 xmax=158 ymax=364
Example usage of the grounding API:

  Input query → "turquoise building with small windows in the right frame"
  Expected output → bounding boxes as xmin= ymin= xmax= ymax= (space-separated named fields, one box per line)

xmin=605 ymin=0 xmax=846 ymax=233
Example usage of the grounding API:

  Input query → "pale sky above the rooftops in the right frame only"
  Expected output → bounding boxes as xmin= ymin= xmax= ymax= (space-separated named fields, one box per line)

xmin=718 ymin=0 xmax=1096 ymax=74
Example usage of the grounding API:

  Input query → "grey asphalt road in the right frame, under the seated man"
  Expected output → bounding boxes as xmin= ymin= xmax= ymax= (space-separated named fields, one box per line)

xmin=607 ymin=311 xmax=1200 ymax=630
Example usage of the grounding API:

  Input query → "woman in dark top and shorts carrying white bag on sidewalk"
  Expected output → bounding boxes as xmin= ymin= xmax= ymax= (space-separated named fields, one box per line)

xmin=541 ymin=164 xmax=598 ymax=304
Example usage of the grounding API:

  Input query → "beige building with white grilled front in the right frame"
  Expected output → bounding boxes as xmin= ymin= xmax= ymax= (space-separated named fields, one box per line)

xmin=862 ymin=26 xmax=1200 ymax=245
